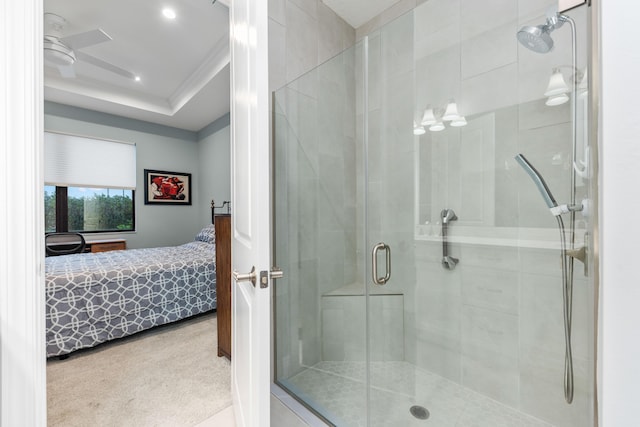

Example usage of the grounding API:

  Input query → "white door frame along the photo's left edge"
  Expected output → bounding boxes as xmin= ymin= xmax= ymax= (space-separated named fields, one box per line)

xmin=0 ymin=0 xmax=47 ymax=426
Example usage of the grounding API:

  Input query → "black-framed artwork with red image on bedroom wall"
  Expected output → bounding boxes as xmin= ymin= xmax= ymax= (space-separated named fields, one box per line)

xmin=144 ymin=169 xmax=191 ymax=205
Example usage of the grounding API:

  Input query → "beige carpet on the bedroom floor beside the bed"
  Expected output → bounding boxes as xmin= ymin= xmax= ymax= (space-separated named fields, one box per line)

xmin=47 ymin=313 xmax=231 ymax=427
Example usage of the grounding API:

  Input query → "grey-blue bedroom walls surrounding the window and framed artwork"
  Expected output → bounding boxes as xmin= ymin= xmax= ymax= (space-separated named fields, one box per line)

xmin=44 ymin=102 xmax=230 ymax=249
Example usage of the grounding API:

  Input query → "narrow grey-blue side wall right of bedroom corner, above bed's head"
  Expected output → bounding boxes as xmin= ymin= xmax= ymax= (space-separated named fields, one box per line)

xmin=197 ymin=114 xmax=231 ymax=227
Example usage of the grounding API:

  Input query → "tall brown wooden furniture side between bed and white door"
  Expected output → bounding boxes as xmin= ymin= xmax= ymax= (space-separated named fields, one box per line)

xmin=214 ymin=214 xmax=231 ymax=360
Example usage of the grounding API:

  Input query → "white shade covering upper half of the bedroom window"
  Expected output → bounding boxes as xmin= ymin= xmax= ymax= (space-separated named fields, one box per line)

xmin=44 ymin=132 xmax=136 ymax=190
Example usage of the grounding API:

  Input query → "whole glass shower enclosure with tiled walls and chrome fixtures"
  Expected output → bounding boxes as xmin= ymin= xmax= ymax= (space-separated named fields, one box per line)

xmin=273 ymin=0 xmax=595 ymax=426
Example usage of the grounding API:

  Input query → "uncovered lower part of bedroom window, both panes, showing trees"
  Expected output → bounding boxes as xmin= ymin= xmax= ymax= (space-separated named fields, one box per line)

xmin=44 ymin=185 xmax=135 ymax=233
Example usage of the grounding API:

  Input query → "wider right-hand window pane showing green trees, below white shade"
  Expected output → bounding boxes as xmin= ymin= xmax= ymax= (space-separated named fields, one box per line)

xmin=67 ymin=187 xmax=133 ymax=231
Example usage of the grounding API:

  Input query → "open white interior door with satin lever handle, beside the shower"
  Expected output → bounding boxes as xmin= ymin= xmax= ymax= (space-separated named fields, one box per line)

xmin=229 ymin=0 xmax=271 ymax=426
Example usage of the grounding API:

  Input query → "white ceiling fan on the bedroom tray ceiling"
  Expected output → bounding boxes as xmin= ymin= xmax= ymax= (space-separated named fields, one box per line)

xmin=44 ymin=13 xmax=136 ymax=80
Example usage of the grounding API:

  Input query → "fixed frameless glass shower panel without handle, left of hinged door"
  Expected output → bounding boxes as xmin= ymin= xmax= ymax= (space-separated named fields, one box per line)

xmin=274 ymin=40 xmax=366 ymax=425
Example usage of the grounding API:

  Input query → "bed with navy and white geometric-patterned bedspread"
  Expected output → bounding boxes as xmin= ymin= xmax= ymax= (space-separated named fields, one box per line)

xmin=45 ymin=225 xmax=216 ymax=357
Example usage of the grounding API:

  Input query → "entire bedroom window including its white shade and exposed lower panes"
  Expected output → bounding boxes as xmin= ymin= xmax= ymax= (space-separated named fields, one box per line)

xmin=44 ymin=132 xmax=136 ymax=232
